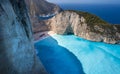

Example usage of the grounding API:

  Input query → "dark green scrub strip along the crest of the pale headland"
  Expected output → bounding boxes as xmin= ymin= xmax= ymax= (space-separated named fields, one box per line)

xmin=66 ymin=10 xmax=113 ymax=29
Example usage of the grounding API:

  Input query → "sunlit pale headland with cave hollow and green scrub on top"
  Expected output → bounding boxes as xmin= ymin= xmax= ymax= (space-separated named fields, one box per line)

xmin=48 ymin=10 xmax=120 ymax=44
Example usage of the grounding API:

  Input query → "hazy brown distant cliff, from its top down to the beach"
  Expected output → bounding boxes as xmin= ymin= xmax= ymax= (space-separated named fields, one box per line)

xmin=25 ymin=0 xmax=62 ymax=33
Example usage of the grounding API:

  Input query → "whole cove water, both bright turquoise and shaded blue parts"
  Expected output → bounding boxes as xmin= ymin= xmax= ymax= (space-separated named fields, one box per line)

xmin=35 ymin=35 xmax=120 ymax=74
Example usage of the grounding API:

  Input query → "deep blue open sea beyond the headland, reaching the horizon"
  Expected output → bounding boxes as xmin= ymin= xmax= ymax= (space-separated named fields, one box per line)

xmin=59 ymin=4 xmax=120 ymax=24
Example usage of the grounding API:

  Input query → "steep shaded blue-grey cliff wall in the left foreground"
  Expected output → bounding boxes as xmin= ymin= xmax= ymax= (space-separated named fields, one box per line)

xmin=0 ymin=0 xmax=46 ymax=74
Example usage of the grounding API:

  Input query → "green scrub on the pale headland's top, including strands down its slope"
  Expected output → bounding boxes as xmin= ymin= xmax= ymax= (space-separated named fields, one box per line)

xmin=63 ymin=10 xmax=114 ymax=34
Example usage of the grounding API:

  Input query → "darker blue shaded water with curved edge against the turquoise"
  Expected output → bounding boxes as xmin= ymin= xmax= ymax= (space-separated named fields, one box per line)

xmin=35 ymin=37 xmax=85 ymax=74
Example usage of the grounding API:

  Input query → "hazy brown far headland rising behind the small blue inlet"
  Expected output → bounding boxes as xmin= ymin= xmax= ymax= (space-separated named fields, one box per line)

xmin=25 ymin=0 xmax=61 ymax=16
